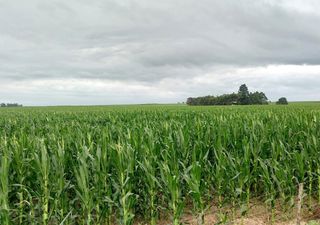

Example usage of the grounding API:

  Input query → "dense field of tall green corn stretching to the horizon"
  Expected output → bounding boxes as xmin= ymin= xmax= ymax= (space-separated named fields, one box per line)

xmin=0 ymin=102 xmax=320 ymax=225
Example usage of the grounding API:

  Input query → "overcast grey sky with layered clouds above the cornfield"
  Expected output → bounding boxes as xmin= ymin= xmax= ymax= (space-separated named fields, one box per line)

xmin=0 ymin=0 xmax=320 ymax=105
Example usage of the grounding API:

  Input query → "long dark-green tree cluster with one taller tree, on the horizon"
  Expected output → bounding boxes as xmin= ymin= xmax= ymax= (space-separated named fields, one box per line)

xmin=187 ymin=84 xmax=268 ymax=105
